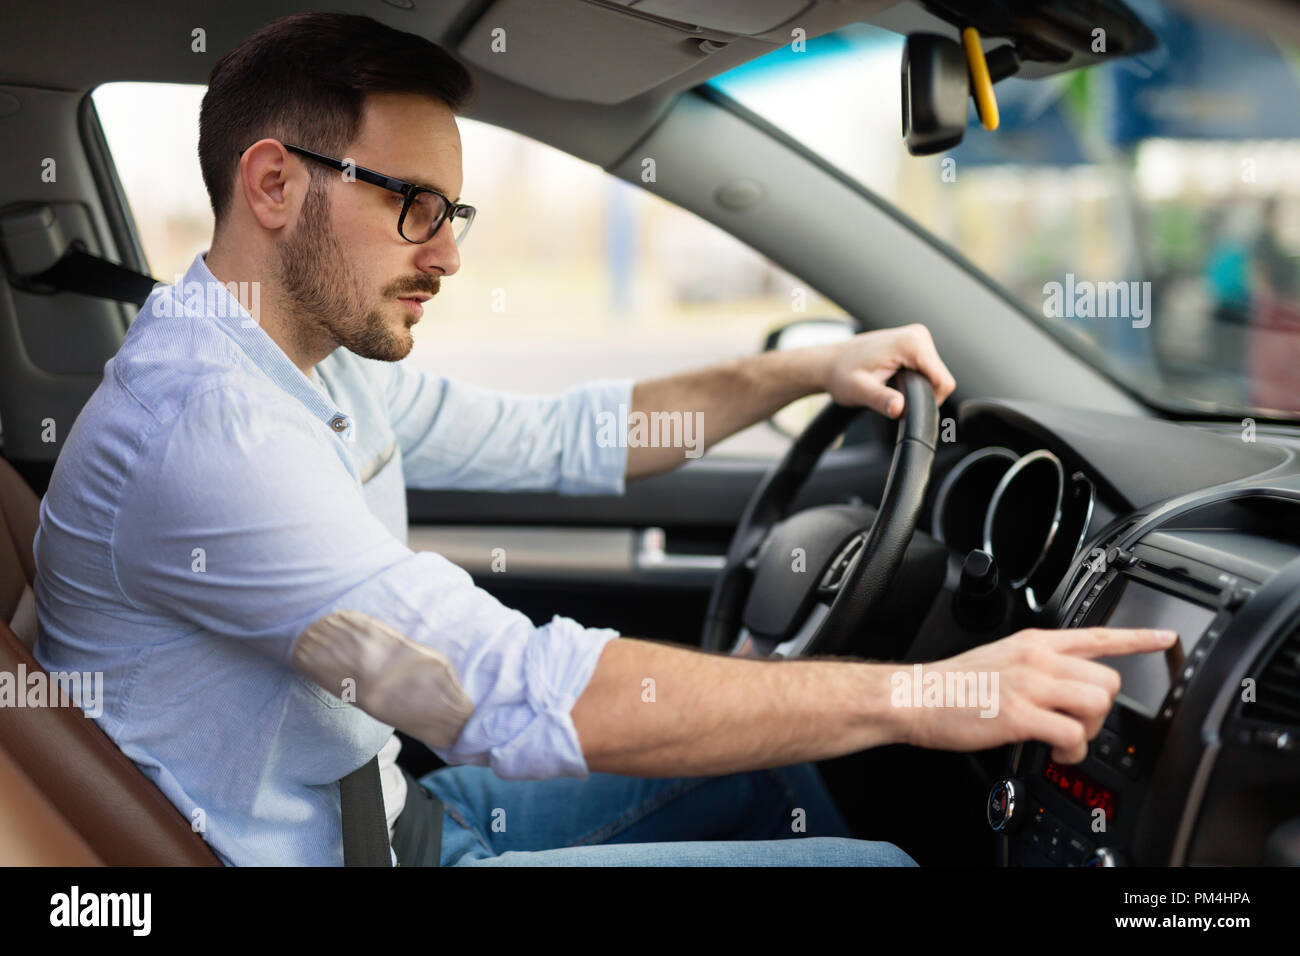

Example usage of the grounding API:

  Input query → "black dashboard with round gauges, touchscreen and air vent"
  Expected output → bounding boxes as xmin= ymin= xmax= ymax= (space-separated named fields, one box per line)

xmin=930 ymin=401 xmax=1300 ymax=866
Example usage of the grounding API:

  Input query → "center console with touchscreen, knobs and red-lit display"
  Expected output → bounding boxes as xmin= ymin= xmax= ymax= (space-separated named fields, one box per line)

xmin=987 ymin=494 xmax=1300 ymax=866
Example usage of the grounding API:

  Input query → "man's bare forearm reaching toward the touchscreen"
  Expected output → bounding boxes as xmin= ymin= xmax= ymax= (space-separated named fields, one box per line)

xmin=572 ymin=639 xmax=906 ymax=777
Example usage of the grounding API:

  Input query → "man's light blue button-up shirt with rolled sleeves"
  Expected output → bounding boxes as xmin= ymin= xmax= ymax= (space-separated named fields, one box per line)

xmin=34 ymin=254 xmax=632 ymax=865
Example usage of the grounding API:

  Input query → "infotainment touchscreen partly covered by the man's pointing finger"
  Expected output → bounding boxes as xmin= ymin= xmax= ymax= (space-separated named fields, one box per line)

xmin=1097 ymin=579 xmax=1216 ymax=717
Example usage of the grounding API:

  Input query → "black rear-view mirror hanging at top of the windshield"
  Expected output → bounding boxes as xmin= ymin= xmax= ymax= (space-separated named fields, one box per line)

xmin=902 ymin=34 xmax=971 ymax=156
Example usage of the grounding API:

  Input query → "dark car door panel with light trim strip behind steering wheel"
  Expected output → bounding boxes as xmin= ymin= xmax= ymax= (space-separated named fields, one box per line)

xmin=407 ymin=441 xmax=891 ymax=644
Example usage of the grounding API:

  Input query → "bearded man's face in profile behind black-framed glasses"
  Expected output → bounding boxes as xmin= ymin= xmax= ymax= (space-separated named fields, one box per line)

xmin=276 ymin=94 xmax=462 ymax=362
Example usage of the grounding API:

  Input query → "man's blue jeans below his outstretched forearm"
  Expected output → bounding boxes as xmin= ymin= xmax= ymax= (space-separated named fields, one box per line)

xmin=420 ymin=763 xmax=917 ymax=866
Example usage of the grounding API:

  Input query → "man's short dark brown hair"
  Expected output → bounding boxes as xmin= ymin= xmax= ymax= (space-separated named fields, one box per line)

xmin=199 ymin=13 xmax=475 ymax=222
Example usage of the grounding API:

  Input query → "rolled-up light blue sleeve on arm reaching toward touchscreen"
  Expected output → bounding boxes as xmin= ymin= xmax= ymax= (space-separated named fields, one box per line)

xmin=113 ymin=386 xmax=619 ymax=778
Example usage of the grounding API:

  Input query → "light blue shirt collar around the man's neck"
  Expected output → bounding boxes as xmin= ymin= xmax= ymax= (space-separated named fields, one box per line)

xmin=174 ymin=250 xmax=354 ymax=441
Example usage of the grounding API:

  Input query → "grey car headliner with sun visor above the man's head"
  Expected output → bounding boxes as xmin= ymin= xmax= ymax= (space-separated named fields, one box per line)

xmin=0 ymin=0 xmax=1284 ymax=168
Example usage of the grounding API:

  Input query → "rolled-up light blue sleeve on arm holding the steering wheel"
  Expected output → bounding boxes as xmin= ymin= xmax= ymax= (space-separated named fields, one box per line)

xmin=372 ymin=362 xmax=634 ymax=494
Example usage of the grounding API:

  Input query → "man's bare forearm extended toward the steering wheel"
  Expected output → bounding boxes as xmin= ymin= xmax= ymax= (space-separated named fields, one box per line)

xmin=627 ymin=346 xmax=833 ymax=479
